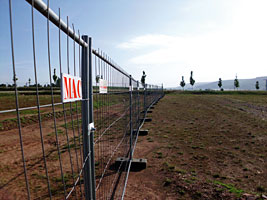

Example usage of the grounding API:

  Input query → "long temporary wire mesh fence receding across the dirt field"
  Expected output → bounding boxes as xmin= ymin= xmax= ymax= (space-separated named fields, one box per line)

xmin=0 ymin=0 xmax=164 ymax=199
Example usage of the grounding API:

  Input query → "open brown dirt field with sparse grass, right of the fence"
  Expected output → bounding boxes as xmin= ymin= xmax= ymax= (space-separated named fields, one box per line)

xmin=125 ymin=93 xmax=267 ymax=200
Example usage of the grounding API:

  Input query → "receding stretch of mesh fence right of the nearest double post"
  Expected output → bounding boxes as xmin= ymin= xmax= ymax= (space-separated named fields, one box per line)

xmin=92 ymin=50 xmax=163 ymax=199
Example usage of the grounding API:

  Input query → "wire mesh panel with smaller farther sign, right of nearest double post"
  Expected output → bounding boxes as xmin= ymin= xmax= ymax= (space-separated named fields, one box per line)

xmin=93 ymin=51 xmax=130 ymax=199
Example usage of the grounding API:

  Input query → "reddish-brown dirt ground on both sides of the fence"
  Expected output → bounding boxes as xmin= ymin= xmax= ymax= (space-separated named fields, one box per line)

xmin=0 ymin=94 xmax=267 ymax=200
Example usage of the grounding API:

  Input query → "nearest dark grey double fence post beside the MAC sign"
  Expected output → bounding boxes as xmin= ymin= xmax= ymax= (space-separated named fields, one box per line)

xmin=82 ymin=35 xmax=95 ymax=200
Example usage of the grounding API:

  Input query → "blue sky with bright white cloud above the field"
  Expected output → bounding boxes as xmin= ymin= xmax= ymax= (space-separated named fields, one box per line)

xmin=0 ymin=0 xmax=267 ymax=87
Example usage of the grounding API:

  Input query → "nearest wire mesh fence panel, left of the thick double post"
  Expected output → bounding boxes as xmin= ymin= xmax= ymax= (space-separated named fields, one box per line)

xmin=0 ymin=0 xmax=84 ymax=199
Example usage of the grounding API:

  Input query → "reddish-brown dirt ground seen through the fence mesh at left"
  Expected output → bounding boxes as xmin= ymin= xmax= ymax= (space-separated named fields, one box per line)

xmin=0 ymin=92 xmax=133 ymax=200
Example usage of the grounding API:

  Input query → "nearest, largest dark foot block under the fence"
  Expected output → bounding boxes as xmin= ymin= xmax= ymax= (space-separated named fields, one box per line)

xmin=115 ymin=157 xmax=147 ymax=172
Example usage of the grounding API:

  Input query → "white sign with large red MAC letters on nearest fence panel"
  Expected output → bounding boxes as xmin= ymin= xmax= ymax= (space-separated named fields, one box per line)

xmin=61 ymin=73 xmax=82 ymax=103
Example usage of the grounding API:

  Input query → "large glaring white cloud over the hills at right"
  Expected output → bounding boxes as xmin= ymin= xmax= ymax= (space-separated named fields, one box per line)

xmin=118 ymin=0 xmax=267 ymax=84
